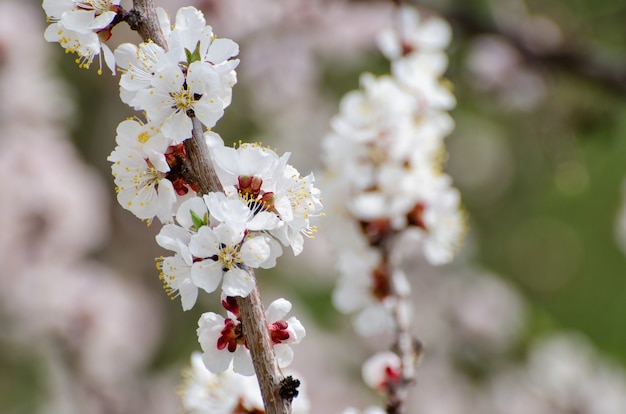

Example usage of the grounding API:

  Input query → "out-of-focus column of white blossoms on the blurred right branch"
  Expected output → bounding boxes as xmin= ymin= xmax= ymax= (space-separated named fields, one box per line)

xmin=323 ymin=7 xmax=464 ymax=335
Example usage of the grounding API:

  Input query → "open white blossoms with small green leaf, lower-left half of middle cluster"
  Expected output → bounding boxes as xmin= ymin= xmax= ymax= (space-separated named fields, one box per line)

xmin=157 ymin=193 xmax=282 ymax=299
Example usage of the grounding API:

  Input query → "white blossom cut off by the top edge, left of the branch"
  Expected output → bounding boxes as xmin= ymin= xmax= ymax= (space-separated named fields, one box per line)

xmin=43 ymin=0 xmax=120 ymax=73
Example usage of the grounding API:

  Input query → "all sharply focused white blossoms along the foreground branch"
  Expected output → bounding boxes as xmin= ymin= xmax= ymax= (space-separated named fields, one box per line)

xmin=44 ymin=0 xmax=322 ymax=402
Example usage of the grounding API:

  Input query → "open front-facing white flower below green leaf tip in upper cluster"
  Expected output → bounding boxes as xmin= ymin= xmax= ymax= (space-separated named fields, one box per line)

xmin=131 ymin=62 xmax=224 ymax=143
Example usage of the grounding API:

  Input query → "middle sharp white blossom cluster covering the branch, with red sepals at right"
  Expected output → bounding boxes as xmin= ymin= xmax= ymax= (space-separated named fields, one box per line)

xmin=157 ymin=144 xmax=321 ymax=310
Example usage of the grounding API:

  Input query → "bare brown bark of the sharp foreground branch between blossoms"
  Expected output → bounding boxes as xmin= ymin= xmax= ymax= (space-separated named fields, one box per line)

xmin=131 ymin=0 xmax=291 ymax=414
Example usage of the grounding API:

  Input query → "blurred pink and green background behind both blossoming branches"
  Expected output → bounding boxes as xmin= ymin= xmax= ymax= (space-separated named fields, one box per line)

xmin=0 ymin=0 xmax=626 ymax=414
